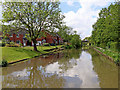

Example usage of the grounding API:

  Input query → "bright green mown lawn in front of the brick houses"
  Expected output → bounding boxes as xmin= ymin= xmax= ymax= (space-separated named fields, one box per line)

xmin=0 ymin=45 xmax=62 ymax=63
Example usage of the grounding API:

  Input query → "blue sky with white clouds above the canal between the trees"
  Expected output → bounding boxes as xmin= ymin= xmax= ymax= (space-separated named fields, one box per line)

xmin=0 ymin=0 xmax=115 ymax=39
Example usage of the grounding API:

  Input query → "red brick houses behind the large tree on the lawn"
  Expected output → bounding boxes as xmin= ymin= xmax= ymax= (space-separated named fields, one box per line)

xmin=1 ymin=32 xmax=63 ymax=46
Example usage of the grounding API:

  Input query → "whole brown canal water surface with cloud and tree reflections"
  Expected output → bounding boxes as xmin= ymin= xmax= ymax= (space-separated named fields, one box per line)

xmin=2 ymin=49 xmax=118 ymax=88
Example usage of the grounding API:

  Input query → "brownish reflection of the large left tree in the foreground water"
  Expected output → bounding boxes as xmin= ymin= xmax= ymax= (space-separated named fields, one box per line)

xmin=2 ymin=60 xmax=64 ymax=88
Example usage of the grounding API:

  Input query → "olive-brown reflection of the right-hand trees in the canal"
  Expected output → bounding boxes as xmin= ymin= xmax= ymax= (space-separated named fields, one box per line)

xmin=88 ymin=49 xmax=118 ymax=88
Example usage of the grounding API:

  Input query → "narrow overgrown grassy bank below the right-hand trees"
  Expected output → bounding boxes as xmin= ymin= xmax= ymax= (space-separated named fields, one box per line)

xmin=94 ymin=46 xmax=120 ymax=64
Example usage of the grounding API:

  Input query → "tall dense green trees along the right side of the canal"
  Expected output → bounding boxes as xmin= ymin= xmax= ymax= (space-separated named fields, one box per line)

xmin=90 ymin=2 xmax=120 ymax=50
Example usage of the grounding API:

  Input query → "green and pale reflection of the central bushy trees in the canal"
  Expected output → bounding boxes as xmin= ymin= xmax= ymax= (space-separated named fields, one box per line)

xmin=58 ymin=49 xmax=81 ymax=73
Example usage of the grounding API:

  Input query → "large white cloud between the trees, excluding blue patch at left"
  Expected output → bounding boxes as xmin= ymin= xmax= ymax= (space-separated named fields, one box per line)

xmin=64 ymin=0 xmax=114 ymax=39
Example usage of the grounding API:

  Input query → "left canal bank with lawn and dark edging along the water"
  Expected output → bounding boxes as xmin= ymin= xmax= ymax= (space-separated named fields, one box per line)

xmin=1 ymin=45 xmax=63 ymax=64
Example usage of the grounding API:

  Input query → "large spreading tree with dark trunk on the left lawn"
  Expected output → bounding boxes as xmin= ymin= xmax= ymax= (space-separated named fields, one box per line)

xmin=3 ymin=2 xmax=64 ymax=51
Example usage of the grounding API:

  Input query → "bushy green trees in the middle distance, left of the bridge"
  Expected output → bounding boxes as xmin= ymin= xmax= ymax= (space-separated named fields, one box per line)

xmin=57 ymin=25 xmax=81 ymax=48
